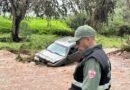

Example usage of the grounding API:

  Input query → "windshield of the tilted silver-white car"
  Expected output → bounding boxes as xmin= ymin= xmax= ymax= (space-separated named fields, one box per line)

xmin=47 ymin=43 xmax=67 ymax=56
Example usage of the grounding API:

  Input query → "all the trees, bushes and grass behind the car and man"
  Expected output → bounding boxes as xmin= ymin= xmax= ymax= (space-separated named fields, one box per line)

xmin=0 ymin=0 xmax=130 ymax=50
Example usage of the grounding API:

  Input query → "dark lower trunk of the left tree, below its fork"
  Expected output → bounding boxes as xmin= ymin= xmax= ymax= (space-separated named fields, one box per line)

xmin=12 ymin=16 xmax=21 ymax=42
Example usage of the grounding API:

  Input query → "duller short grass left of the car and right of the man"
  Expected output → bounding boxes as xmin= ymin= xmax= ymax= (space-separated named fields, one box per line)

xmin=0 ymin=34 xmax=122 ymax=51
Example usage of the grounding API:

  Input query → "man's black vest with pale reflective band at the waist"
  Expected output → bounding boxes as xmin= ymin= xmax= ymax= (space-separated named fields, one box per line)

xmin=69 ymin=45 xmax=111 ymax=90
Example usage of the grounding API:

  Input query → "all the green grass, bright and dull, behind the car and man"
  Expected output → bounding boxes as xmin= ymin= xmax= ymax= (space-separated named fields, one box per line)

xmin=0 ymin=16 xmax=126 ymax=50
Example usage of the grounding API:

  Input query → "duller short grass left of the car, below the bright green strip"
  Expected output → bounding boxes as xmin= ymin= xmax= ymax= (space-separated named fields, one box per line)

xmin=0 ymin=34 xmax=59 ymax=51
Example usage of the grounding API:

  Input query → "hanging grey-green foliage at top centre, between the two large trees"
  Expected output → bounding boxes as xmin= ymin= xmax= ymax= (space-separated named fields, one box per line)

xmin=33 ymin=0 xmax=67 ymax=18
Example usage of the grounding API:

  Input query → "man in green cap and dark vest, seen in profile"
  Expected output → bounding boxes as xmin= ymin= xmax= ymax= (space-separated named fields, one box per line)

xmin=69 ymin=25 xmax=111 ymax=90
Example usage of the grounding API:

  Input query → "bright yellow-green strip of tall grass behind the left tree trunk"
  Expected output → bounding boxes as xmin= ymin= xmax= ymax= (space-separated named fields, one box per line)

xmin=0 ymin=16 xmax=73 ymax=36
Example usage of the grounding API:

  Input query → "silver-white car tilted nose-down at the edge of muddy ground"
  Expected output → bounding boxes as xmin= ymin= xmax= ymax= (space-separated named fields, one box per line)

xmin=34 ymin=37 xmax=80 ymax=66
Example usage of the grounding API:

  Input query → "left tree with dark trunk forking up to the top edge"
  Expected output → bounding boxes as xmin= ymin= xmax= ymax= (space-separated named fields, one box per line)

xmin=9 ymin=0 xmax=30 ymax=42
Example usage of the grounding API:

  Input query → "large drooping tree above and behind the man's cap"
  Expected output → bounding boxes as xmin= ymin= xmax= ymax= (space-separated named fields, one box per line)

xmin=68 ymin=0 xmax=115 ymax=30
